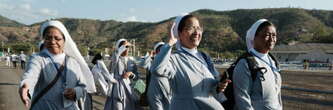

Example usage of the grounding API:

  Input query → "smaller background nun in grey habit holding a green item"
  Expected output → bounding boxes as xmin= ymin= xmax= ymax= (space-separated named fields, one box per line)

xmin=104 ymin=39 xmax=139 ymax=110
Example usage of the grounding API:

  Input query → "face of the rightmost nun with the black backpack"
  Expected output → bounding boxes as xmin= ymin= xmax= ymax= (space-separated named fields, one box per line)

xmin=253 ymin=26 xmax=277 ymax=53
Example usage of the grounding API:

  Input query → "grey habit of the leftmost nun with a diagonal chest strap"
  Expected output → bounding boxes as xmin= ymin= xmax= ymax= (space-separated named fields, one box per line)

xmin=21 ymin=50 xmax=86 ymax=110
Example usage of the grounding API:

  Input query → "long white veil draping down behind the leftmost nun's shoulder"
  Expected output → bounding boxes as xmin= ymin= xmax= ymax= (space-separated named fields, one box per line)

xmin=40 ymin=20 xmax=96 ymax=93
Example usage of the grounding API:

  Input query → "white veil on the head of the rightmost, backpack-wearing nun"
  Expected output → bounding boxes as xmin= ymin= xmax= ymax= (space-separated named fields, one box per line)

xmin=246 ymin=19 xmax=268 ymax=51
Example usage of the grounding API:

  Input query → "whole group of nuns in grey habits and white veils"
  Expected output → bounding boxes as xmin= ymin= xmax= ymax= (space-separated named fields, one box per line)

xmin=13 ymin=14 xmax=282 ymax=110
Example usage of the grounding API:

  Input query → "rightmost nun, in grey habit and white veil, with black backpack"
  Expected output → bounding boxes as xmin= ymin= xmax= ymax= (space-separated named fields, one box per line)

xmin=232 ymin=19 xmax=282 ymax=110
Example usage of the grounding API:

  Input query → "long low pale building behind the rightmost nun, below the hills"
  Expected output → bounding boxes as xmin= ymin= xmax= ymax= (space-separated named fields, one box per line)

xmin=271 ymin=43 xmax=333 ymax=62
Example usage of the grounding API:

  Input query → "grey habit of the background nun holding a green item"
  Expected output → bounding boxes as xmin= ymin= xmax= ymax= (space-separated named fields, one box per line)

xmin=104 ymin=51 xmax=139 ymax=110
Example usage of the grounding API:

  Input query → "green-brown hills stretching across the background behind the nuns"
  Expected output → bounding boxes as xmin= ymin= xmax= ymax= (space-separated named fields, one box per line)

xmin=0 ymin=8 xmax=333 ymax=57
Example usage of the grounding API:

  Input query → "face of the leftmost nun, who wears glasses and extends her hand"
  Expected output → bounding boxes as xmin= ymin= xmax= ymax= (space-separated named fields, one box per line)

xmin=44 ymin=27 xmax=65 ymax=54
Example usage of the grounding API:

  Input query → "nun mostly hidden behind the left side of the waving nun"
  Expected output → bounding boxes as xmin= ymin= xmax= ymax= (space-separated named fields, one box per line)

xmin=139 ymin=42 xmax=171 ymax=110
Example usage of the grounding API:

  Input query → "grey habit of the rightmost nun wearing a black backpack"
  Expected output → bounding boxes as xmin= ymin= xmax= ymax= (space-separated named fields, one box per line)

xmin=232 ymin=49 xmax=282 ymax=110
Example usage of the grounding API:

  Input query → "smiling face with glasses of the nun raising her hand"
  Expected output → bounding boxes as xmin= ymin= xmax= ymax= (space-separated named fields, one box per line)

xmin=179 ymin=17 xmax=202 ymax=49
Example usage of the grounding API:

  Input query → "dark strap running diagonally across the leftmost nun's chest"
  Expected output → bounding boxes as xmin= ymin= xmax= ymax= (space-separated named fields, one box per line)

xmin=30 ymin=56 xmax=67 ymax=110
